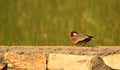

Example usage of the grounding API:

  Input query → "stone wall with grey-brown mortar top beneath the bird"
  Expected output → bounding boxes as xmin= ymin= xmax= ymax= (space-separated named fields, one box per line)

xmin=0 ymin=46 xmax=120 ymax=70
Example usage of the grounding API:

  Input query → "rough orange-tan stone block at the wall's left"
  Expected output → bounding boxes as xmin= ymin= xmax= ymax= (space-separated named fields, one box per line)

xmin=4 ymin=52 xmax=46 ymax=70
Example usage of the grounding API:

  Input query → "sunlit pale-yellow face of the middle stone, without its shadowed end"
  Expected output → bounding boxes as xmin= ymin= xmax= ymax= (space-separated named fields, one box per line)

xmin=48 ymin=53 xmax=94 ymax=70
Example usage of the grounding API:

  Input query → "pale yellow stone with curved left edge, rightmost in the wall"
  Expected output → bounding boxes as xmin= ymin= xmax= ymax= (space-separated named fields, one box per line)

xmin=102 ymin=54 xmax=120 ymax=69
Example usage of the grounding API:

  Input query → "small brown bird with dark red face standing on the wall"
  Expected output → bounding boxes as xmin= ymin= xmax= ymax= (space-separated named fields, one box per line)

xmin=70 ymin=31 xmax=93 ymax=45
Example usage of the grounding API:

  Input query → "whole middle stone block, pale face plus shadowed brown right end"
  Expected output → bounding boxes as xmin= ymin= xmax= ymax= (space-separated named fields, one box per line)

xmin=48 ymin=53 xmax=112 ymax=70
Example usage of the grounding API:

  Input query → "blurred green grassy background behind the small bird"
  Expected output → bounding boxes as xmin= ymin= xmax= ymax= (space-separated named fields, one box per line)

xmin=0 ymin=0 xmax=120 ymax=46
